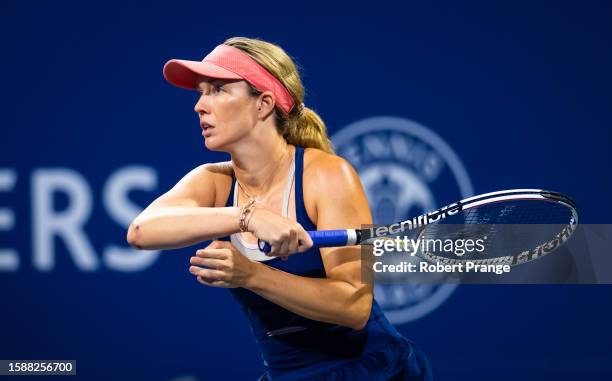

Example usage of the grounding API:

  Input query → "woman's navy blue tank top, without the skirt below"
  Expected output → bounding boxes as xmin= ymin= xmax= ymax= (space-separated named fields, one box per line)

xmin=223 ymin=147 xmax=402 ymax=381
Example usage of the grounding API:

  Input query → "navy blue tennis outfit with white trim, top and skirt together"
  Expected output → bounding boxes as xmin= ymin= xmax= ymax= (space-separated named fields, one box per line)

xmin=224 ymin=147 xmax=432 ymax=381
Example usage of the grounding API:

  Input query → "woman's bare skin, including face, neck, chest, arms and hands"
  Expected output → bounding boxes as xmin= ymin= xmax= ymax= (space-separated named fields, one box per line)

xmin=127 ymin=78 xmax=372 ymax=329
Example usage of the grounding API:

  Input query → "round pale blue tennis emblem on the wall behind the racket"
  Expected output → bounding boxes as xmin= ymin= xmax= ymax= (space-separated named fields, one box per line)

xmin=332 ymin=116 xmax=474 ymax=324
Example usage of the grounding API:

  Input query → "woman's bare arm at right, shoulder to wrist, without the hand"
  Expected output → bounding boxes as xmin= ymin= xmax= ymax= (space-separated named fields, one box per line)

xmin=244 ymin=152 xmax=372 ymax=330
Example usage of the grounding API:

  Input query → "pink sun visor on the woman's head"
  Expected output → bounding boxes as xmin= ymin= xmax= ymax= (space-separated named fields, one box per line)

xmin=164 ymin=45 xmax=294 ymax=114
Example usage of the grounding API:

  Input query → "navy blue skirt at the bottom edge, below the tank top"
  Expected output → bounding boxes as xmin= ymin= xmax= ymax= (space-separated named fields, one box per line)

xmin=258 ymin=337 xmax=433 ymax=381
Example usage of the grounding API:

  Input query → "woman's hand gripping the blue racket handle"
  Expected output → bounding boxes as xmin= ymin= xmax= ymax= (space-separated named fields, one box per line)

xmin=249 ymin=207 xmax=312 ymax=257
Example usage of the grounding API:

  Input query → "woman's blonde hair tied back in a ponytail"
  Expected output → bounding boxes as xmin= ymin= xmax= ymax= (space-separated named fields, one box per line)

xmin=223 ymin=37 xmax=334 ymax=153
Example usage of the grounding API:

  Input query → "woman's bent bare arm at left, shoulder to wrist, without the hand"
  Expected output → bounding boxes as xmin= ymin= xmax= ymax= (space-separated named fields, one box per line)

xmin=127 ymin=163 xmax=240 ymax=250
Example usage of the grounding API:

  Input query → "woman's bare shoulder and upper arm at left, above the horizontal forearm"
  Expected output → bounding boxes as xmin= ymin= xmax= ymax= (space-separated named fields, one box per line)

xmin=151 ymin=162 xmax=233 ymax=207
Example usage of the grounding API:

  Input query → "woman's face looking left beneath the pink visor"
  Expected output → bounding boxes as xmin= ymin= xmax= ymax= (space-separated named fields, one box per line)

xmin=194 ymin=77 xmax=257 ymax=151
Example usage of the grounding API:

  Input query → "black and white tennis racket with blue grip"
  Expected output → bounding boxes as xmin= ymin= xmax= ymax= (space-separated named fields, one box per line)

xmin=258 ymin=189 xmax=578 ymax=265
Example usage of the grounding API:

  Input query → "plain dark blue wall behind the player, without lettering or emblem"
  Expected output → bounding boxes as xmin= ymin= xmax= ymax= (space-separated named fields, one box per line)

xmin=0 ymin=2 xmax=612 ymax=380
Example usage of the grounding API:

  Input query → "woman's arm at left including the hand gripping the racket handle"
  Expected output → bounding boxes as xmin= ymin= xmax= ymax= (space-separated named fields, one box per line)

xmin=127 ymin=163 xmax=312 ymax=255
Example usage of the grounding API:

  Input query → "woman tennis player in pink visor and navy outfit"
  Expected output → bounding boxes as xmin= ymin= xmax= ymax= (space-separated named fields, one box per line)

xmin=128 ymin=37 xmax=431 ymax=380
